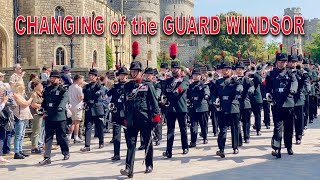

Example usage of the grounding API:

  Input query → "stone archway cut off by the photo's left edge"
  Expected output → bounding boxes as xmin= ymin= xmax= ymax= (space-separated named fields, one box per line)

xmin=0 ymin=26 xmax=9 ymax=68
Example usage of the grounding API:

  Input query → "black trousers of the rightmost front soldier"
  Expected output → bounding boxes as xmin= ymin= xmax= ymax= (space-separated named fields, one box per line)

xmin=271 ymin=107 xmax=294 ymax=150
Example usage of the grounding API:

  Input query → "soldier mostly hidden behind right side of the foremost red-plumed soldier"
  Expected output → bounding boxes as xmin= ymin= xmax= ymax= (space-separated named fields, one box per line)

xmin=144 ymin=68 xmax=162 ymax=146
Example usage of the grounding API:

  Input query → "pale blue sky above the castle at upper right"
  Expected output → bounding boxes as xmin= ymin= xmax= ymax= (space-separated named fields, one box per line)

xmin=194 ymin=0 xmax=320 ymax=41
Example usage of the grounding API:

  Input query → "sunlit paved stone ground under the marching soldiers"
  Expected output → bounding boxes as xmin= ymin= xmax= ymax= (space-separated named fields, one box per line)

xmin=0 ymin=114 xmax=320 ymax=180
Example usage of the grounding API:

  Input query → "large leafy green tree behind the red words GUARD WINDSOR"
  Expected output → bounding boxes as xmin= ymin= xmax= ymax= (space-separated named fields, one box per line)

xmin=202 ymin=12 xmax=265 ymax=64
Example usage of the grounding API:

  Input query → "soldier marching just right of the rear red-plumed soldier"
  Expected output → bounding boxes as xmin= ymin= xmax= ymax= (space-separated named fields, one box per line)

xmin=187 ymin=68 xmax=210 ymax=148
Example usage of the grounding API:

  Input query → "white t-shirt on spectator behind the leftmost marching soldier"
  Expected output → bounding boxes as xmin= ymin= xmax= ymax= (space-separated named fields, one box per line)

xmin=69 ymin=84 xmax=83 ymax=110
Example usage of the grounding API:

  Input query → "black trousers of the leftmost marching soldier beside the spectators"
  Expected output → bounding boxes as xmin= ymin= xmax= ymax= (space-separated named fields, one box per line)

xmin=44 ymin=120 xmax=69 ymax=158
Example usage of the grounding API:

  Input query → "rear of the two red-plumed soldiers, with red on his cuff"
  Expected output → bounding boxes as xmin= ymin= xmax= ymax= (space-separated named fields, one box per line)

xmin=163 ymin=61 xmax=189 ymax=158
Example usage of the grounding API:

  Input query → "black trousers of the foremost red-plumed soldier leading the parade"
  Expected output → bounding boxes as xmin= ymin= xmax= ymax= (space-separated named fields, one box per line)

xmin=126 ymin=123 xmax=153 ymax=173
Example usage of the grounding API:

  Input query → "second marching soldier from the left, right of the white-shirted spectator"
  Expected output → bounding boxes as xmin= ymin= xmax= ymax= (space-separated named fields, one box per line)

xmin=80 ymin=69 xmax=106 ymax=152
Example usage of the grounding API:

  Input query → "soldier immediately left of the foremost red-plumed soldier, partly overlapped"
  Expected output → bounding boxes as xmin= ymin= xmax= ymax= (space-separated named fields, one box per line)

xmin=107 ymin=66 xmax=129 ymax=161
